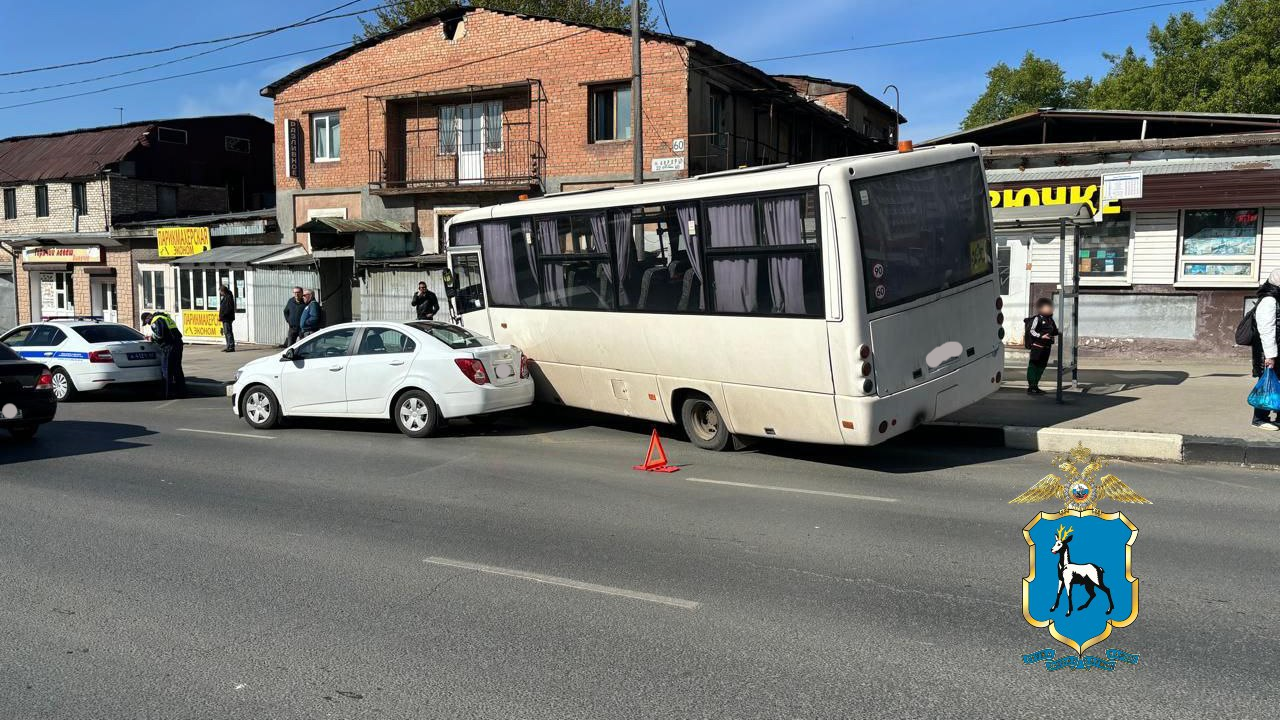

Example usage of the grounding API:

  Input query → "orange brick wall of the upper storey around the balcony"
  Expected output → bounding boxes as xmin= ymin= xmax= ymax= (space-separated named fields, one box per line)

xmin=275 ymin=10 xmax=689 ymax=198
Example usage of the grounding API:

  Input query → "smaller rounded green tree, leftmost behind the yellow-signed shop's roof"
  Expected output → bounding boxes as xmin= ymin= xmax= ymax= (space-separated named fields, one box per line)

xmin=960 ymin=51 xmax=1092 ymax=129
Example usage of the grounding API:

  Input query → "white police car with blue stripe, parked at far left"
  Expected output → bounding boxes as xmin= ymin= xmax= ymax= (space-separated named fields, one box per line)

xmin=0 ymin=318 xmax=160 ymax=400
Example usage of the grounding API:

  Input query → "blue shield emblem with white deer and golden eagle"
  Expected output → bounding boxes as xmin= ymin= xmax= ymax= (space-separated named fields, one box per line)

xmin=1009 ymin=445 xmax=1151 ymax=670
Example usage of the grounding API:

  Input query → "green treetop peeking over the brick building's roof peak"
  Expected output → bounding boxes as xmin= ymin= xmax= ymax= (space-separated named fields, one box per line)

xmin=356 ymin=0 xmax=654 ymax=40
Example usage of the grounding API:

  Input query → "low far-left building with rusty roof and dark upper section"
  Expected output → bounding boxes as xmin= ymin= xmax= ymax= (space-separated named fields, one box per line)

xmin=0 ymin=115 xmax=275 ymax=324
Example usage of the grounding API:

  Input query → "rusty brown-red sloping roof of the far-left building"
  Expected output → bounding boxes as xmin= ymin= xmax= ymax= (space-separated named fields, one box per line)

xmin=0 ymin=123 xmax=154 ymax=183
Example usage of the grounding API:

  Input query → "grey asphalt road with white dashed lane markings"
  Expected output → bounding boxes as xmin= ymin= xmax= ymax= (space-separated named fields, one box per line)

xmin=0 ymin=398 xmax=1280 ymax=720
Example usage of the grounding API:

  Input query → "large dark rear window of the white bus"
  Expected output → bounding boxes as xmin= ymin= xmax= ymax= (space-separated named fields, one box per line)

xmin=851 ymin=158 xmax=992 ymax=313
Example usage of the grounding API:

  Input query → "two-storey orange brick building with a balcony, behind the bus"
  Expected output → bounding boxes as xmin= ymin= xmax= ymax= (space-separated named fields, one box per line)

xmin=262 ymin=8 xmax=893 ymax=319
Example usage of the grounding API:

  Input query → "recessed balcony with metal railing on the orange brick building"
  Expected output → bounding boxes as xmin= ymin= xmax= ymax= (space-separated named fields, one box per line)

xmin=369 ymin=81 xmax=547 ymax=193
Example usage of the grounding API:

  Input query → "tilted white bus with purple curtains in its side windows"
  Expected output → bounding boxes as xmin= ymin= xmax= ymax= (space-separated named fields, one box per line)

xmin=448 ymin=145 xmax=1004 ymax=450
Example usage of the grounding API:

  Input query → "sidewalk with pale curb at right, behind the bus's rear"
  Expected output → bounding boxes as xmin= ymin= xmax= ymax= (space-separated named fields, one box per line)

xmin=934 ymin=351 xmax=1280 ymax=465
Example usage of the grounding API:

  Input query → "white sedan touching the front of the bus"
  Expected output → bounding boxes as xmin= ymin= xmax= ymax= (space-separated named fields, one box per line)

xmin=232 ymin=322 xmax=534 ymax=437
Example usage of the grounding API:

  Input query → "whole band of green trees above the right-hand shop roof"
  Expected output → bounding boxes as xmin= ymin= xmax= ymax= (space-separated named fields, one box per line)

xmin=964 ymin=0 xmax=1280 ymax=128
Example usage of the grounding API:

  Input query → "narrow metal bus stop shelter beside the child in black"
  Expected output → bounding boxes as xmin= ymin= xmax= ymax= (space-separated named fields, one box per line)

xmin=991 ymin=202 xmax=1094 ymax=402
